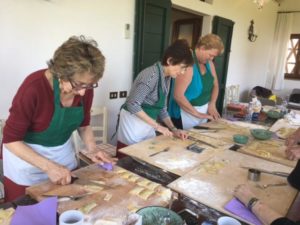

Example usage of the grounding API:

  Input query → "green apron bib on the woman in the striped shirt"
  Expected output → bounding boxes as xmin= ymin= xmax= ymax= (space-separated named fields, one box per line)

xmin=142 ymin=64 xmax=166 ymax=120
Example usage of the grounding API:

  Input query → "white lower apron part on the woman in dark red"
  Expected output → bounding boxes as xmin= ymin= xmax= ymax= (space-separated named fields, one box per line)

xmin=3 ymin=139 xmax=77 ymax=186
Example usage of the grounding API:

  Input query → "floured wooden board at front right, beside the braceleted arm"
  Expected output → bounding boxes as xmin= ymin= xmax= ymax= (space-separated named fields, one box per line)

xmin=168 ymin=150 xmax=297 ymax=225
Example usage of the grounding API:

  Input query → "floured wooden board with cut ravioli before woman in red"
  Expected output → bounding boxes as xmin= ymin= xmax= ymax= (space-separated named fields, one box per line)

xmin=26 ymin=164 xmax=171 ymax=224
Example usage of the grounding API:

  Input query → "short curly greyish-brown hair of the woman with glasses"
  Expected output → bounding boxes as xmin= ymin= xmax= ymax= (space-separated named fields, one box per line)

xmin=48 ymin=36 xmax=105 ymax=82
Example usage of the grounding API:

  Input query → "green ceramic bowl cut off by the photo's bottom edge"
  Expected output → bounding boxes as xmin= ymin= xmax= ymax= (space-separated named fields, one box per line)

xmin=137 ymin=206 xmax=183 ymax=225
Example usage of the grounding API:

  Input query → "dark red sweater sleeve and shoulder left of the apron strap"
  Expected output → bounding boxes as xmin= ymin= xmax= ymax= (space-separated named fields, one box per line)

xmin=3 ymin=70 xmax=54 ymax=143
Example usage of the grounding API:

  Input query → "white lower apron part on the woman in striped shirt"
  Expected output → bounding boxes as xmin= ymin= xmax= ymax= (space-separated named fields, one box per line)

xmin=117 ymin=109 xmax=156 ymax=145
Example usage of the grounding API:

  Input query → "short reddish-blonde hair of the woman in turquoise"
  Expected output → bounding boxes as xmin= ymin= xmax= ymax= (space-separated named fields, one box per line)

xmin=196 ymin=34 xmax=224 ymax=55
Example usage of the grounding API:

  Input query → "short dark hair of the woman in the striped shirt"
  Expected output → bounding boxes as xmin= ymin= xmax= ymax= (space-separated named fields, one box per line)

xmin=161 ymin=39 xmax=194 ymax=66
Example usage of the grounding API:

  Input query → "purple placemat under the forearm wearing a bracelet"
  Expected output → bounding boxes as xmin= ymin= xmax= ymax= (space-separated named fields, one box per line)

xmin=224 ymin=198 xmax=262 ymax=225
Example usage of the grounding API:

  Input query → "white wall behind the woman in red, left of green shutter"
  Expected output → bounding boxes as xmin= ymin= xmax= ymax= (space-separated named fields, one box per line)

xmin=0 ymin=0 xmax=135 ymax=144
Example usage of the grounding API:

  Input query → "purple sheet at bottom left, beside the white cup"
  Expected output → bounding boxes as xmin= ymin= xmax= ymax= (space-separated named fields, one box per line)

xmin=10 ymin=197 xmax=57 ymax=225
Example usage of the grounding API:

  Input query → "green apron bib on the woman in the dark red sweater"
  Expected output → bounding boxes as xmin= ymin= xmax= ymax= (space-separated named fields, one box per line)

xmin=24 ymin=78 xmax=84 ymax=147
